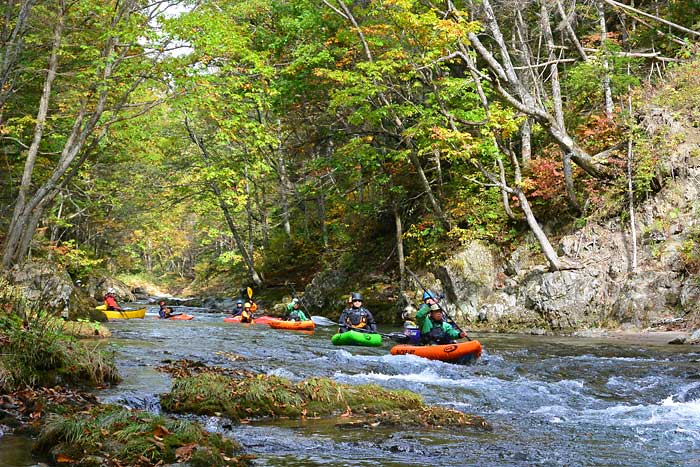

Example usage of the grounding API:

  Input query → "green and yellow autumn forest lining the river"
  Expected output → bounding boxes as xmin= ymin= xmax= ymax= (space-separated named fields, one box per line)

xmin=0 ymin=0 xmax=700 ymax=300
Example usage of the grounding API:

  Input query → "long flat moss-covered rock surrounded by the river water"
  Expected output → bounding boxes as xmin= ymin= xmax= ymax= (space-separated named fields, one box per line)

xmin=161 ymin=365 xmax=488 ymax=428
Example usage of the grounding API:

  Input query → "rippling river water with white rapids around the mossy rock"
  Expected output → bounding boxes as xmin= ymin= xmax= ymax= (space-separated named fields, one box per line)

xmin=0 ymin=308 xmax=700 ymax=467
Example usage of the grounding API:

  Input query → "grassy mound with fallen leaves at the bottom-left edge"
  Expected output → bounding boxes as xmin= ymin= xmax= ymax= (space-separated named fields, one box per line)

xmin=35 ymin=405 xmax=250 ymax=467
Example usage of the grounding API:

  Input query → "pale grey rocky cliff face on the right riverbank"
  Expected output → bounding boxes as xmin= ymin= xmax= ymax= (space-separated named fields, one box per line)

xmin=427 ymin=109 xmax=700 ymax=330
